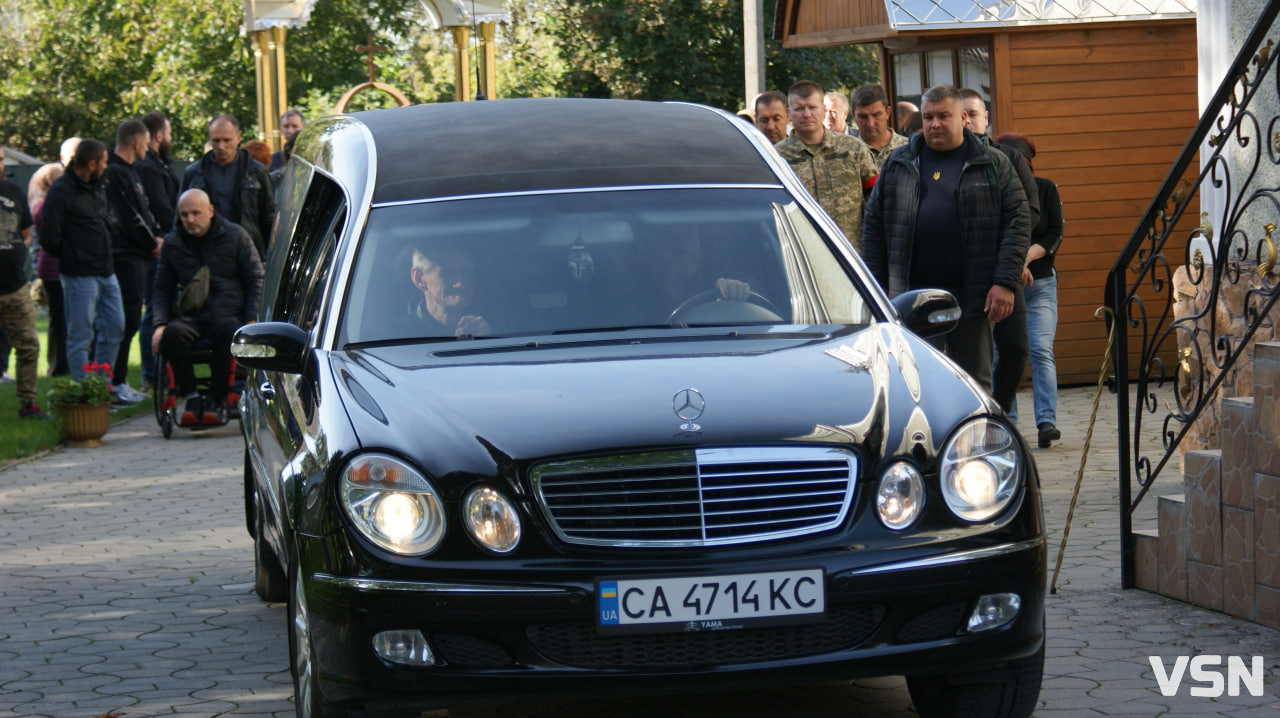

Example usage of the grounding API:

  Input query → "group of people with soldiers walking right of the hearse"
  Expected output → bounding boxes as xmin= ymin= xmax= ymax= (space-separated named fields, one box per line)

xmin=742 ymin=81 xmax=1062 ymax=448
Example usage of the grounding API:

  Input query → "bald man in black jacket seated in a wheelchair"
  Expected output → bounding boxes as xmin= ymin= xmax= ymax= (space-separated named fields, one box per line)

xmin=151 ymin=189 xmax=262 ymax=426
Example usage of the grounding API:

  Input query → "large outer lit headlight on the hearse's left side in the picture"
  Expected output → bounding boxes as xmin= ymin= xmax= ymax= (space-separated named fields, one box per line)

xmin=342 ymin=454 xmax=444 ymax=555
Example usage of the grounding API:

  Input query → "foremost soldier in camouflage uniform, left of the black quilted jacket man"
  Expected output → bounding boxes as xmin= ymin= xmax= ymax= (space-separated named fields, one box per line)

xmin=776 ymin=81 xmax=879 ymax=253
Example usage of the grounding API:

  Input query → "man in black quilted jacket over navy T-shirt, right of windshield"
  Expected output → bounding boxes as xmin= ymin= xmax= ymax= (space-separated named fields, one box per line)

xmin=863 ymin=84 xmax=1030 ymax=393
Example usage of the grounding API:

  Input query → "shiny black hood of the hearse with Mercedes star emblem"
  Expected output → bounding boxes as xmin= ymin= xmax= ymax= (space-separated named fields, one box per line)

xmin=329 ymin=323 xmax=997 ymax=476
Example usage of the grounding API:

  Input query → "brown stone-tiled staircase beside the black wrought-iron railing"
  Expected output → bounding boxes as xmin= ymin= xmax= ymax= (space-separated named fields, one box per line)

xmin=1134 ymin=342 xmax=1280 ymax=628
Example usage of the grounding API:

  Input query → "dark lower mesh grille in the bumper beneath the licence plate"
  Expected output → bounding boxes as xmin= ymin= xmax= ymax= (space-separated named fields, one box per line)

xmin=527 ymin=605 xmax=884 ymax=668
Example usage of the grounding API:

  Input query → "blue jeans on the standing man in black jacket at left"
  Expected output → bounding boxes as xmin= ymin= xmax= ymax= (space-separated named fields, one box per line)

xmin=63 ymin=274 xmax=124 ymax=380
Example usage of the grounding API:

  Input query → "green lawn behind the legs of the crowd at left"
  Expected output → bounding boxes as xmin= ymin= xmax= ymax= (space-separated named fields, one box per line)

xmin=0 ymin=315 xmax=152 ymax=463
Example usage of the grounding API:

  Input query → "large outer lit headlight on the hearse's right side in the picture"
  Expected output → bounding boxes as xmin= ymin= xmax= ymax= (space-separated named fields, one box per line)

xmin=938 ymin=419 xmax=1021 ymax=521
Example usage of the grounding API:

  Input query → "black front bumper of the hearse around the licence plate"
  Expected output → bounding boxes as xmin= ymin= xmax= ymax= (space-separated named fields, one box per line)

xmin=305 ymin=538 xmax=1046 ymax=710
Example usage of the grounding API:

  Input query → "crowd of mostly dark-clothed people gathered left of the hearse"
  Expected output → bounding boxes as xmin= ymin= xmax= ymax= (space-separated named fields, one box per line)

xmin=0 ymin=110 xmax=305 ymax=425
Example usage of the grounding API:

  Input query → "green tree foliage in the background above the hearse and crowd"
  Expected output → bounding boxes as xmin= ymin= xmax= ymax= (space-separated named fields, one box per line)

xmin=0 ymin=0 xmax=877 ymax=157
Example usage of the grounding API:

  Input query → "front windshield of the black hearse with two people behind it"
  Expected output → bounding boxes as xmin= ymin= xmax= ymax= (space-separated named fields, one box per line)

xmin=340 ymin=188 xmax=870 ymax=346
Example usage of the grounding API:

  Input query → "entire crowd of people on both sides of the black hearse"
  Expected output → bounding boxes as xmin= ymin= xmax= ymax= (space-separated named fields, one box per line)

xmin=0 ymin=89 xmax=1062 ymax=447
